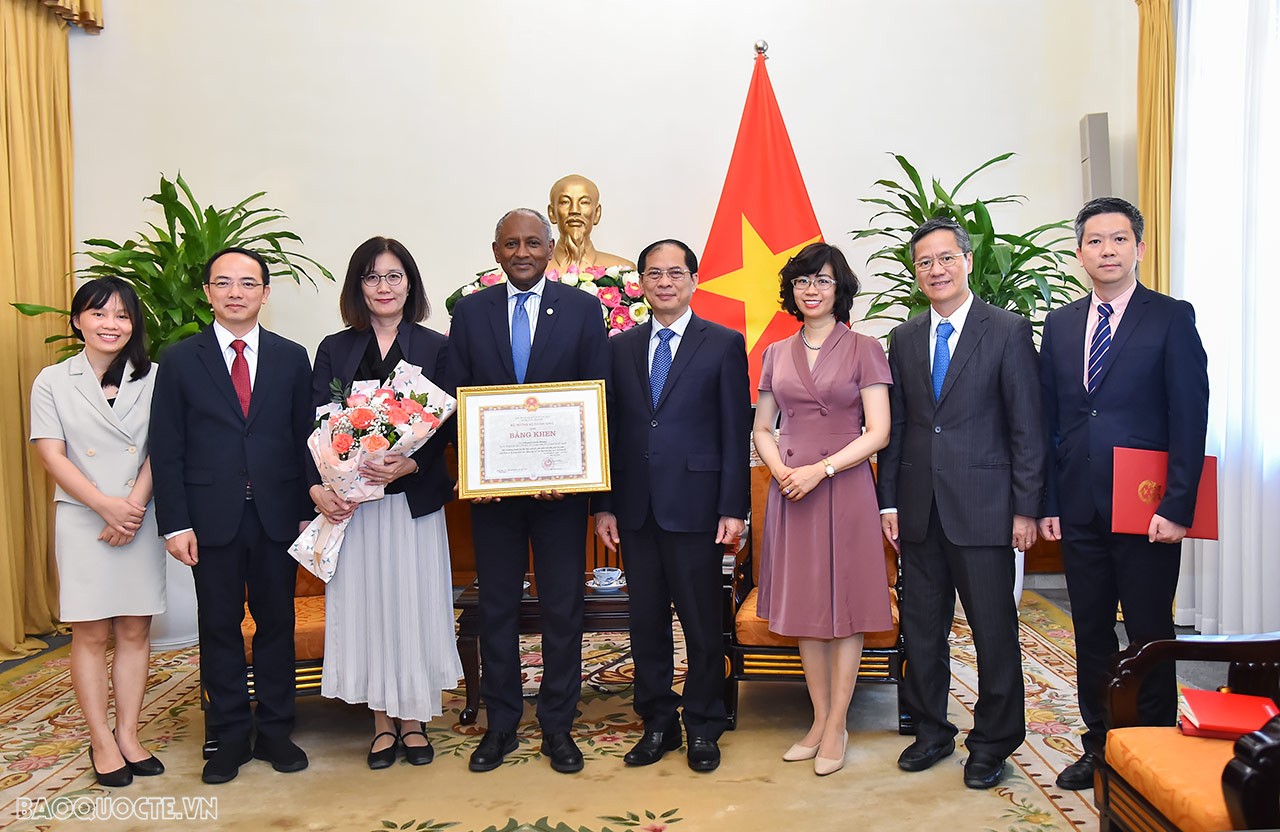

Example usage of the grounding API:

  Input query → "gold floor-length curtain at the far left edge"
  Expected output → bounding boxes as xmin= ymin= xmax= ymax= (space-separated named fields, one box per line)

xmin=0 ymin=0 xmax=94 ymax=659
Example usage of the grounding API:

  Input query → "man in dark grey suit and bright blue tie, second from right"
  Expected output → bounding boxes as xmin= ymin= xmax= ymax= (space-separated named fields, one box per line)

xmin=877 ymin=219 xmax=1044 ymax=788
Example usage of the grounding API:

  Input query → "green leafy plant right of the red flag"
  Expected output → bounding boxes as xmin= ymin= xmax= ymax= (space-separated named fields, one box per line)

xmin=851 ymin=152 xmax=1084 ymax=326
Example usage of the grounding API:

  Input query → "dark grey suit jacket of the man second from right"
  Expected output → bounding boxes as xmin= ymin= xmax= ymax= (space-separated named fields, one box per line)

xmin=877 ymin=297 xmax=1044 ymax=547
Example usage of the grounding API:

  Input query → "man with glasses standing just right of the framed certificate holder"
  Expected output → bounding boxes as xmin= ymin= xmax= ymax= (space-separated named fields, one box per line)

xmin=595 ymin=239 xmax=751 ymax=772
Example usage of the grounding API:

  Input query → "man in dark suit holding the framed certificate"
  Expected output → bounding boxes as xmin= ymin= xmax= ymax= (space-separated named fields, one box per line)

xmin=447 ymin=209 xmax=609 ymax=773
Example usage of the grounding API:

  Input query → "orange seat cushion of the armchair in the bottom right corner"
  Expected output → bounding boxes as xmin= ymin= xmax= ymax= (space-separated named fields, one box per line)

xmin=1106 ymin=727 xmax=1235 ymax=832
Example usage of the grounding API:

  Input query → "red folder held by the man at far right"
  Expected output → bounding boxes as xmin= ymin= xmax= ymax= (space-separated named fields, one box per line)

xmin=1111 ymin=448 xmax=1217 ymax=540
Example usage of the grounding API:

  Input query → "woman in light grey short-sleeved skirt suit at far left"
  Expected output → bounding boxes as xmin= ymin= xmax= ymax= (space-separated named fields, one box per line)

xmin=31 ymin=278 xmax=165 ymax=786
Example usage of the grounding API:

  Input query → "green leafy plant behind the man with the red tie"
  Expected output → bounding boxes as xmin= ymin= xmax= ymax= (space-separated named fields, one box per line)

xmin=13 ymin=174 xmax=334 ymax=358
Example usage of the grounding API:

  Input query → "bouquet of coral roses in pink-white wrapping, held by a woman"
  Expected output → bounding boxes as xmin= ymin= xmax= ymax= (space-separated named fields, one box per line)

xmin=289 ymin=361 xmax=457 ymax=584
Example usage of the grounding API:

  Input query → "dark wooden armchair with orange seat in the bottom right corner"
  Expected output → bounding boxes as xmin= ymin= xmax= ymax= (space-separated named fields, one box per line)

xmin=1094 ymin=632 xmax=1280 ymax=832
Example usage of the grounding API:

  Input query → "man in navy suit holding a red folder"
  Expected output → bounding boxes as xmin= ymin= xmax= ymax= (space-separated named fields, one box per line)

xmin=1041 ymin=197 xmax=1208 ymax=790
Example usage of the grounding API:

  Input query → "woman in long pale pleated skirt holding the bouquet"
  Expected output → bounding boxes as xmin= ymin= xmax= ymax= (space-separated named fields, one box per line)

xmin=311 ymin=237 xmax=462 ymax=769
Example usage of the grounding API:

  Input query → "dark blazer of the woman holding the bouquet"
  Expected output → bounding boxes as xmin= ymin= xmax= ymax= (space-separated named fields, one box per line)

xmin=307 ymin=321 xmax=454 ymax=517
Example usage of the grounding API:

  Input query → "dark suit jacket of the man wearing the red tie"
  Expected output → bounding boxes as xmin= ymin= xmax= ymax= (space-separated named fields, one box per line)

xmin=150 ymin=326 xmax=315 ymax=547
